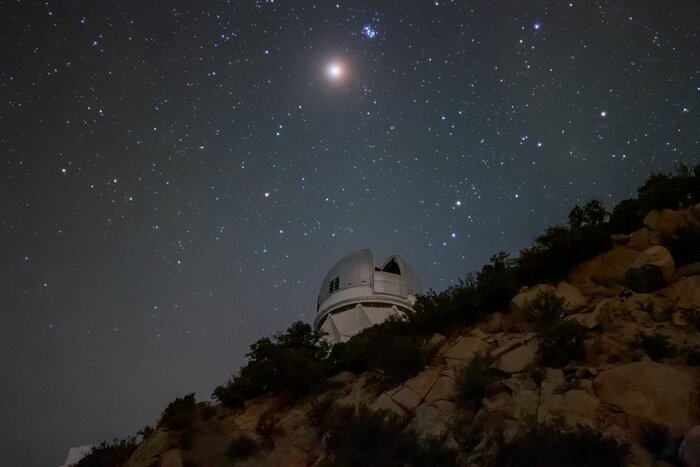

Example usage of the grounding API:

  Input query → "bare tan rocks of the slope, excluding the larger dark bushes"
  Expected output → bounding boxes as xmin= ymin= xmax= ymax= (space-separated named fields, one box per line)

xmin=127 ymin=205 xmax=700 ymax=467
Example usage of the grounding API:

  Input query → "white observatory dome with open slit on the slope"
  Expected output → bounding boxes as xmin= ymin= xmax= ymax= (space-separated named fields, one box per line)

xmin=314 ymin=250 xmax=422 ymax=343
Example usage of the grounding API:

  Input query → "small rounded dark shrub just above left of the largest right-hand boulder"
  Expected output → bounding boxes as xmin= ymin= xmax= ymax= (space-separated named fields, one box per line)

xmin=537 ymin=320 xmax=586 ymax=368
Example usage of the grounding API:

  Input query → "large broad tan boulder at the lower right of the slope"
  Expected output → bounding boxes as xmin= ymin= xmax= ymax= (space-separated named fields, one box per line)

xmin=594 ymin=360 xmax=698 ymax=436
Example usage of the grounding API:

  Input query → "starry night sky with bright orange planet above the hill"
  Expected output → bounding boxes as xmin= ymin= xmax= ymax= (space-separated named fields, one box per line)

xmin=0 ymin=0 xmax=700 ymax=466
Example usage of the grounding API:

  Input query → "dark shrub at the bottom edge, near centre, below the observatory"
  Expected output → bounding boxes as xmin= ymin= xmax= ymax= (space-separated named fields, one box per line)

xmin=319 ymin=406 xmax=455 ymax=467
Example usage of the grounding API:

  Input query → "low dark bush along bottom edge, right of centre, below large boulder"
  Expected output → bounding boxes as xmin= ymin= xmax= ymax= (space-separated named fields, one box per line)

xmin=496 ymin=425 xmax=628 ymax=467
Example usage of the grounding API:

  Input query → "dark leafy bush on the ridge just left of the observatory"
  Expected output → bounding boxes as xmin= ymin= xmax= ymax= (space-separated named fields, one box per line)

xmin=213 ymin=321 xmax=329 ymax=407
